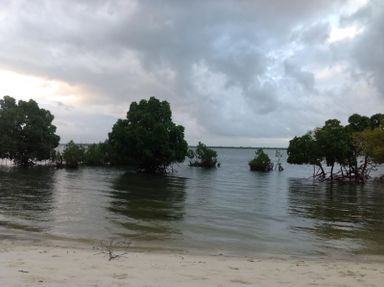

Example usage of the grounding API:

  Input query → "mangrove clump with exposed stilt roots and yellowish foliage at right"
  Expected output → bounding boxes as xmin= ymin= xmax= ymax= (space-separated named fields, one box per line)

xmin=288 ymin=114 xmax=384 ymax=182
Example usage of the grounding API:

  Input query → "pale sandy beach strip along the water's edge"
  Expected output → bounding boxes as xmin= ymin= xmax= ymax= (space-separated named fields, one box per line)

xmin=0 ymin=241 xmax=384 ymax=287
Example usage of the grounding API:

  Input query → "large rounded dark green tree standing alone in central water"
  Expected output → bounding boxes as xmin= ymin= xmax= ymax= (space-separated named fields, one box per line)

xmin=109 ymin=97 xmax=188 ymax=173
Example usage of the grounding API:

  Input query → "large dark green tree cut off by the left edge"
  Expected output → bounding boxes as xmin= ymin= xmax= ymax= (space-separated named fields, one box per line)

xmin=0 ymin=96 xmax=60 ymax=166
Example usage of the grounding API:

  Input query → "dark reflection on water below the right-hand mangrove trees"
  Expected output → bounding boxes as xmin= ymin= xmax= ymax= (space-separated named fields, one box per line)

xmin=289 ymin=179 xmax=384 ymax=254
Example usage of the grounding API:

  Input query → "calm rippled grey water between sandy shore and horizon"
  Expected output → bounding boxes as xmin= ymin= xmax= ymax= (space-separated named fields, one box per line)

xmin=0 ymin=149 xmax=384 ymax=255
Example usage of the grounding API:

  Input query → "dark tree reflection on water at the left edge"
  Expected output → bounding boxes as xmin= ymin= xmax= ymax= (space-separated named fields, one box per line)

xmin=0 ymin=167 xmax=55 ymax=231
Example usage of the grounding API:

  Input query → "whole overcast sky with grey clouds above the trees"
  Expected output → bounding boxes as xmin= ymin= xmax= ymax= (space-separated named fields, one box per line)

xmin=0 ymin=0 xmax=384 ymax=147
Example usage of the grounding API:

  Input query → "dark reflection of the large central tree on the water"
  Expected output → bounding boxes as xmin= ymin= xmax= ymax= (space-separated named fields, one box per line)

xmin=109 ymin=173 xmax=186 ymax=240
